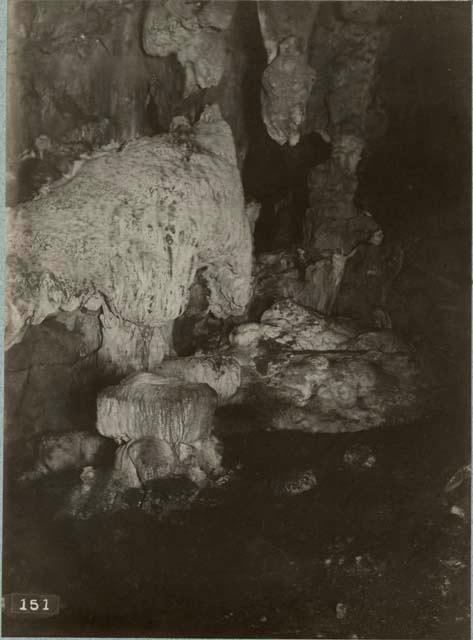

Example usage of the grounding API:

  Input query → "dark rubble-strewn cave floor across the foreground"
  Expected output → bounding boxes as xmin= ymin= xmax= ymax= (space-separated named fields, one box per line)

xmin=3 ymin=396 xmax=470 ymax=640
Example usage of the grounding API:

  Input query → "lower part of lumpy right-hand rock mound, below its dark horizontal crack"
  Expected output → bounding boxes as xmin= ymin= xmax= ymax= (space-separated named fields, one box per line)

xmin=272 ymin=352 xmax=426 ymax=433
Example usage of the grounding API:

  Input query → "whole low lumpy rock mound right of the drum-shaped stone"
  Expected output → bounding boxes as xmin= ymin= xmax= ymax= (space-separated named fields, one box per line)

xmin=219 ymin=300 xmax=427 ymax=433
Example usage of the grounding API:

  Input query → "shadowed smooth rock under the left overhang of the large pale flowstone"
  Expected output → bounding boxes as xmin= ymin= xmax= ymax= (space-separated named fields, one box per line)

xmin=4 ymin=310 xmax=102 ymax=443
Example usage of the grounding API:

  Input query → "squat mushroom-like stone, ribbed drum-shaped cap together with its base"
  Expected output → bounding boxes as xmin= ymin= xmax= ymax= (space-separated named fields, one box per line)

xmin=97 ymin=373 xmax=220 ymax=487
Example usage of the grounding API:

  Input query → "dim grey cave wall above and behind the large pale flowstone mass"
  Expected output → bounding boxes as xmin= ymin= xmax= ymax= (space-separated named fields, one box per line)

xmin=7 ymin=0 xmax=256 ymax=205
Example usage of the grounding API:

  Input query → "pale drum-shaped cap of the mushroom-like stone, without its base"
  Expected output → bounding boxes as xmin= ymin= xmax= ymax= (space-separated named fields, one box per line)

xmin=97 ymin=373 xmax=217 ymax=444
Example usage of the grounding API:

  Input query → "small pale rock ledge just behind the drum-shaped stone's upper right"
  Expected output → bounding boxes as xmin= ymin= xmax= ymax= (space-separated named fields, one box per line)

xmin=154 ymin=355 xmax=241 ymax=404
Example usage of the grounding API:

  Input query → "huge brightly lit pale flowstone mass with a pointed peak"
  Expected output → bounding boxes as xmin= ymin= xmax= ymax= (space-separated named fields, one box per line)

xmin=6 ymin=107 xmax=252 ymax=372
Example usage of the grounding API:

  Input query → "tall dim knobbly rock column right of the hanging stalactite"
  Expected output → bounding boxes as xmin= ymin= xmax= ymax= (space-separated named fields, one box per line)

xmin=304 ymin=2 xmax=386 ymax=313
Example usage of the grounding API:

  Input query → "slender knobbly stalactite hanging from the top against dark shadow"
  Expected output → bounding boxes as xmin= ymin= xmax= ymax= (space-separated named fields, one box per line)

xmin=258 ymin=2 xmax=319 ymax=146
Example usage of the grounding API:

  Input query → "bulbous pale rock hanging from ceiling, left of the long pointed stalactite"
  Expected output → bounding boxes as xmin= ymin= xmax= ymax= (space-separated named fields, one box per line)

xmin=143 ymin=0 xmax=236 ymax=95
